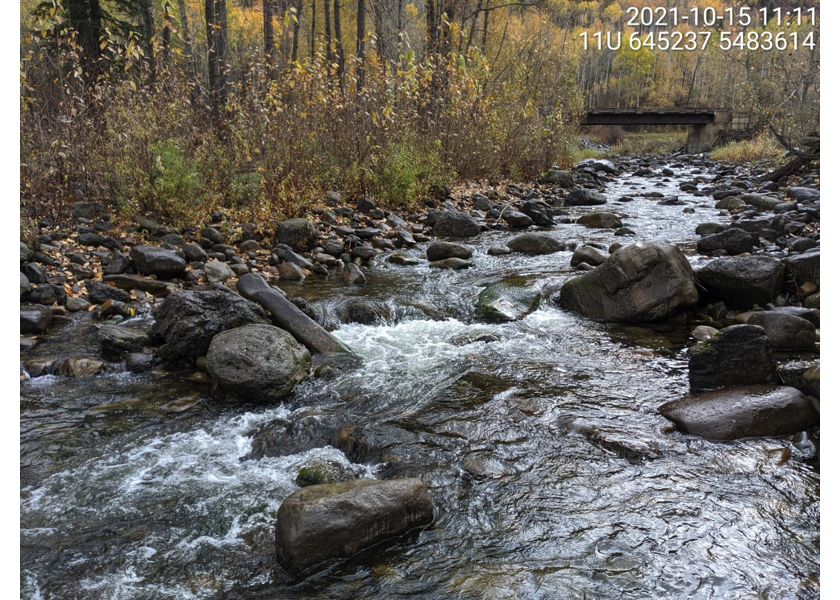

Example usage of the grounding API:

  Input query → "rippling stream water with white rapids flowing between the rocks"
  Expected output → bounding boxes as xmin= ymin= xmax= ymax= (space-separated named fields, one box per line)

xmin=20 ymin=161 xmax=819 ymax=599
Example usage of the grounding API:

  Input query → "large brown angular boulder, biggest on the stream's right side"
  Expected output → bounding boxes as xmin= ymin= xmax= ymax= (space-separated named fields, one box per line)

xmin=560 ymin=242 xmax=697 ymax=322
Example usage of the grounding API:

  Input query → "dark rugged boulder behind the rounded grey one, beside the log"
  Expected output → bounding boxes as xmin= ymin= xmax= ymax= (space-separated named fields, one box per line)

xmin=152 ymin=290 xmax=270 ymax=362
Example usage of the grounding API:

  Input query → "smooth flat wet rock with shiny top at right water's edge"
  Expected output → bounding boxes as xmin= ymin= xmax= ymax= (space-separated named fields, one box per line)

xmin=659 ymin=385 xmax=819 ymax=440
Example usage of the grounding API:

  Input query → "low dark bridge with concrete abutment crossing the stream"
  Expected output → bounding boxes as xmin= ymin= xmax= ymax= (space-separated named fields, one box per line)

xmin=583 ymin=108 xmax=750 ymax=154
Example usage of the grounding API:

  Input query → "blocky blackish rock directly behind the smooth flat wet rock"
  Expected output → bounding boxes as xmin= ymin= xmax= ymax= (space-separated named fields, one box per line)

xmin=688 ymin=325 xmax=779 ymax=392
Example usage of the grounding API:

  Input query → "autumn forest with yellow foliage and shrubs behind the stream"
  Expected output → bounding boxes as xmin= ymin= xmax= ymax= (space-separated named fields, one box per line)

xmin=20 ymin=0 xmax=819 ymax=224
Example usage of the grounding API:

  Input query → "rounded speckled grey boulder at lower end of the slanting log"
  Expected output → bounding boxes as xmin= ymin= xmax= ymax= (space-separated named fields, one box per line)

xmin=207 ymin=325 xmax=312 ymax=402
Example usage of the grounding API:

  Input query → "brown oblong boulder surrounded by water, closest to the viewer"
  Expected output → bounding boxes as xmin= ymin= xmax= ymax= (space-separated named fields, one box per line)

xmin=274 ymin=479 xmax=434 ymax=576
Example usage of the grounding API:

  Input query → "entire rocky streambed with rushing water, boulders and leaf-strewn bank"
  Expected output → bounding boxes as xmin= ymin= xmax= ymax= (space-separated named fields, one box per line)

xmin=21 ymin=156 xmax=819 ymax=598
